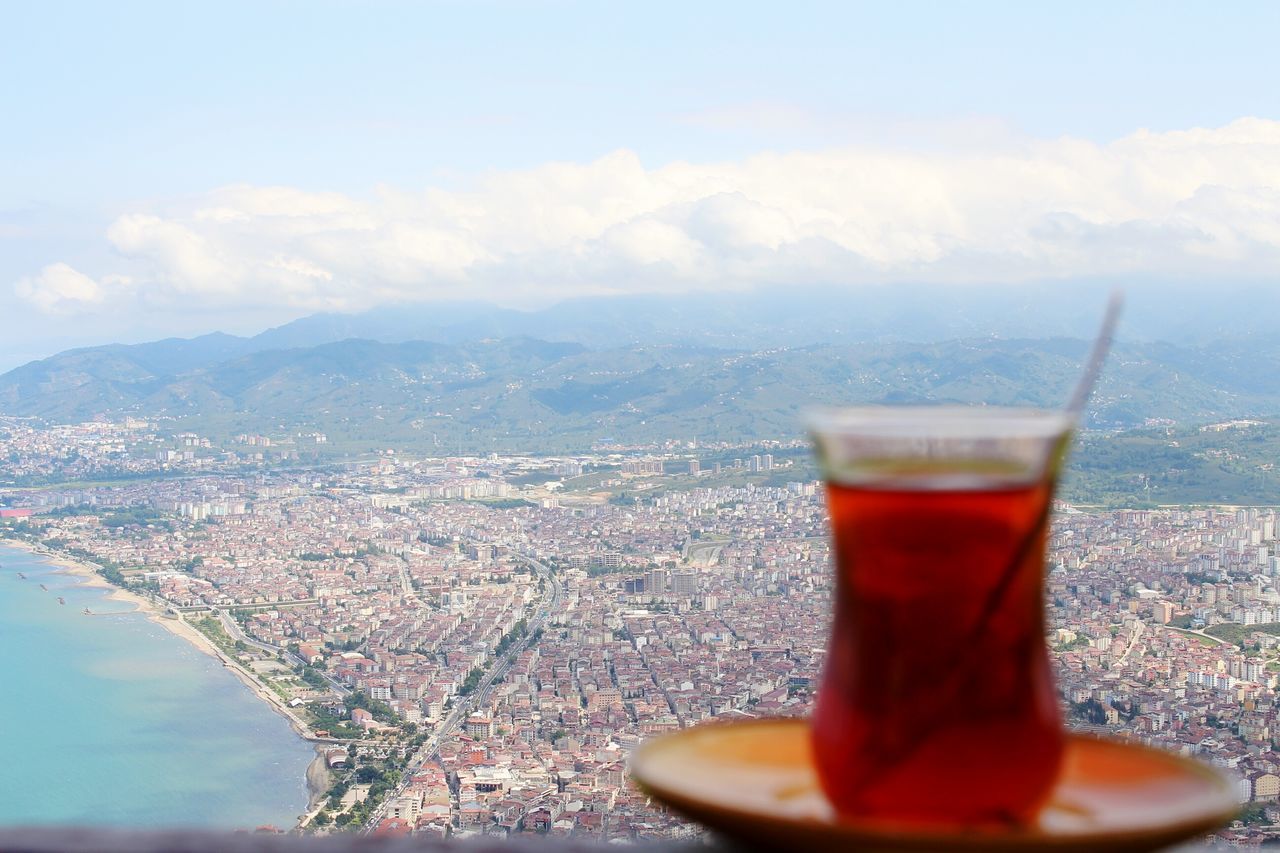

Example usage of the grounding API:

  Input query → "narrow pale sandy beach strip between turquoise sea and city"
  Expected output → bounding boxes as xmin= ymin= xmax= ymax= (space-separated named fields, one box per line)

xmin=0 ymin=539 xmax=330 ymax=816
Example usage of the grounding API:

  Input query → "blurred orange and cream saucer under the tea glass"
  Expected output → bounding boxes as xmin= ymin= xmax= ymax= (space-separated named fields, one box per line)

xmin=631 ymin=719 xmax=1240 ymax=853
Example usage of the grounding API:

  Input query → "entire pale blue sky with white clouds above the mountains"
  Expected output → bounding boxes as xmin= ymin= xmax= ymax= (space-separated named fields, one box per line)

xmin=0 ymin=0 xmax=1280 ymax=369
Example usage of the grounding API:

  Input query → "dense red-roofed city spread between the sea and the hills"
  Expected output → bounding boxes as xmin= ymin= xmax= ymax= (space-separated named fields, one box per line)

xmin=0 ymin=420 xmax=1280 ymax=841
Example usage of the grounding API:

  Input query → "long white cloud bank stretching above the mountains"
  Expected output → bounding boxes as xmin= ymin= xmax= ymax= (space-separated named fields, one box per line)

xmin=15 ymin=118 xmax=1280 ymax=313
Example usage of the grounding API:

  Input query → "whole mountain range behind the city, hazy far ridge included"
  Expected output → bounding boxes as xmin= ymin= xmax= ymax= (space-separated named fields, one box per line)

xmin=0 ymin=283 xmax=1280 ymax=450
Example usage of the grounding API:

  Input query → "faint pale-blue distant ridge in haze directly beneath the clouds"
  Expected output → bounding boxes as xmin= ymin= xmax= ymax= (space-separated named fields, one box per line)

xmin=124 ymin=280 xmax=1280 ymax=352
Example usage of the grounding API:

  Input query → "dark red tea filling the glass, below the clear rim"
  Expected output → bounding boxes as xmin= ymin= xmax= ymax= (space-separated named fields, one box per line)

xmin=813 ymin=478 xmax=1062 ymax=825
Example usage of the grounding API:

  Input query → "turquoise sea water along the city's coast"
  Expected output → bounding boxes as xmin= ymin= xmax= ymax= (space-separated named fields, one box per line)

xmin=0 ymin=544 xmax=315 ymax=829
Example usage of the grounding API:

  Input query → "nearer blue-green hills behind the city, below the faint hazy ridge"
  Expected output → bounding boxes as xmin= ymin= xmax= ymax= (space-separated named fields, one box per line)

xmin=0 ymin=317 xmax=1280 ymax=451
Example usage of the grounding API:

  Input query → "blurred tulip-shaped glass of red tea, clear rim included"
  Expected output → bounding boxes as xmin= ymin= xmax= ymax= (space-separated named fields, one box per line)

xmin=810 ymin=406 xmax=1073 ymax=827
